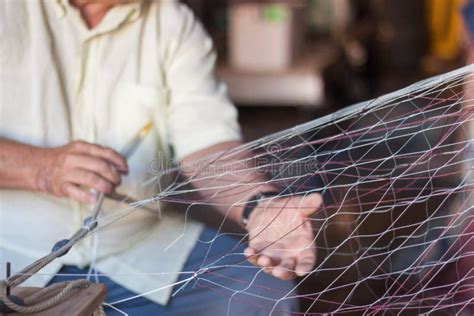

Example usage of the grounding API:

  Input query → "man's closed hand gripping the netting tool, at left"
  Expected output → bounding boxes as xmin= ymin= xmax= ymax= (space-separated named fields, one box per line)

xmin=36 ymin=141 xmax=128 ymax=203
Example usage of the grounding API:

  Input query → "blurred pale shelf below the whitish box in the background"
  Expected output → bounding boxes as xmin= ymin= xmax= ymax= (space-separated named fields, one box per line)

xmin=217 ymin=55 xmax=327 ymax=108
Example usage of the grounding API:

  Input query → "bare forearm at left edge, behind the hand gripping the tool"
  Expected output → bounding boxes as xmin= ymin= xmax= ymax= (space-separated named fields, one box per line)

xmin=0 ymin=138 xmax=42 ymax=190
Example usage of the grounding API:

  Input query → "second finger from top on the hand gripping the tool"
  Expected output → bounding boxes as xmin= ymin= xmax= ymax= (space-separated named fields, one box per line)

xmin=70 ymin=155 xmax=121 ymax=185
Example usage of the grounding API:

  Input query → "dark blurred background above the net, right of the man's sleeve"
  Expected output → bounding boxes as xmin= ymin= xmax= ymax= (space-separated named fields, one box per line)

xmin=183 ymin=0 xmax=465 ymax=140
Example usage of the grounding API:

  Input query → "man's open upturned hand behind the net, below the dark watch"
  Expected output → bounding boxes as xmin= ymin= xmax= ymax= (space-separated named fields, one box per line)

xmin=245 ymin=193 xmax=322 ymax=279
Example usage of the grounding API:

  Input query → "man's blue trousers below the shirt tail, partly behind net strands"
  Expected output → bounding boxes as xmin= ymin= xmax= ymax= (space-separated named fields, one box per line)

xmin=51 ymin=228 xmax=298 ymax=316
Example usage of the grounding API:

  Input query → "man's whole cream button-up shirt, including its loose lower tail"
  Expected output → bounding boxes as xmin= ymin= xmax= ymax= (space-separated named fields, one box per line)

xmin=0 ymin=0 xmax=240 ymax=304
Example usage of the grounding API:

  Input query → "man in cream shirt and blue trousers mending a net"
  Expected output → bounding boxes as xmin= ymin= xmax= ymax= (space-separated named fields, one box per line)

xmin=0 ymin=0 xmax=321 ymax=315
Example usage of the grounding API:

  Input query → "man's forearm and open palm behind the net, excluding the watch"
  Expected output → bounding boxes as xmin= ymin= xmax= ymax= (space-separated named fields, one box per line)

xmin=181 ymin=142 xmax=322 ymax=280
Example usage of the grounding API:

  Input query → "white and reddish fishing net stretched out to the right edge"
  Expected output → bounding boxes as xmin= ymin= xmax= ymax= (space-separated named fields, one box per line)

xmin=2 ymin=65 xmax=474 ymax=314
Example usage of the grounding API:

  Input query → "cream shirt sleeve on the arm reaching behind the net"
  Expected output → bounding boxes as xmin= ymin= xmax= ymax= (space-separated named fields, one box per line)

xmin=161 ymin=1 xmax=241 ymax=161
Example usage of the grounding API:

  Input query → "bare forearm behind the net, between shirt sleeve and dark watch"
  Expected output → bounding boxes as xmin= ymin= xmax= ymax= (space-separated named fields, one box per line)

xmin=181 ymin=141 xmax=278 ymax=223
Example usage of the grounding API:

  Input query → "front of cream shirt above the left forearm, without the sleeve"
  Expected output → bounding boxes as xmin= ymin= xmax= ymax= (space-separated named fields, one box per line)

xmin=0 ymin=1 xmax=169 ymax=200
